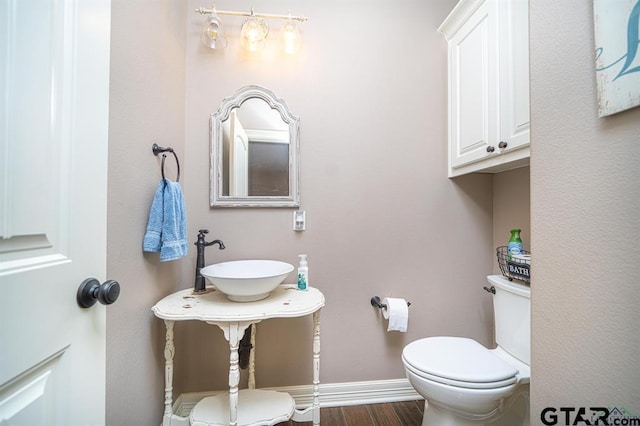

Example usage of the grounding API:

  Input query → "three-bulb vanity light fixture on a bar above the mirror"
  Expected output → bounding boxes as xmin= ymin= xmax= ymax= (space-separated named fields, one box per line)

xmin=196 ymin=6 xmax=307 ymax=54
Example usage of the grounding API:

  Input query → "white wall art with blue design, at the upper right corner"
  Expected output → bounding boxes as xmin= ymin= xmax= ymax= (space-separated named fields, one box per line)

xmin=593 ymin=0 xmax=640 ymax=117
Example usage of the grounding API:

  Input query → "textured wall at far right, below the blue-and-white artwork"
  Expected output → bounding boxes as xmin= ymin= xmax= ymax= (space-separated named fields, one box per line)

xmin=530 ymin=0 xmax=640 ymax=424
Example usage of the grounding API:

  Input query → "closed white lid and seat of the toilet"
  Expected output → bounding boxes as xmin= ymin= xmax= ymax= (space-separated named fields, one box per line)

xmin=402 ymin=336 xmax=518 ymax=383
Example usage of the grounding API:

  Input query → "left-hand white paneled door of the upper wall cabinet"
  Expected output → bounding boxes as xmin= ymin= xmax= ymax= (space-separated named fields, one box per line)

xmin=449 ymin=2 xmax=499 ymax=169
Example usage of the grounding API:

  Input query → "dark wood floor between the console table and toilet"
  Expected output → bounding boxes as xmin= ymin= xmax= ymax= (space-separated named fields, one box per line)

xmin=277 ymin=401 xmax=424 ymax=426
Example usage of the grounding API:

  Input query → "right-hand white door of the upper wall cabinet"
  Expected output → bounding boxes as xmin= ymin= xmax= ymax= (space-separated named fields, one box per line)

xmin=497 ymin=0 xmax=530 ymax=152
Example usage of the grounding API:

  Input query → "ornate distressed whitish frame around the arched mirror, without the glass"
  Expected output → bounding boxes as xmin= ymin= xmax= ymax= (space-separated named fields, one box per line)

xmin=209 ymin=86 xmax=300 ymax=207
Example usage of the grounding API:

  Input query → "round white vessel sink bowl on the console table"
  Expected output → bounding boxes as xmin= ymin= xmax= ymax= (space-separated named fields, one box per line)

xmin=200 ymin=260 xmax=293 ymax=302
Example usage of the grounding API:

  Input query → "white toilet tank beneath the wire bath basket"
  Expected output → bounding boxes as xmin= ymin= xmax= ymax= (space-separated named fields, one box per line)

xmin=487 ymin=275 xmax=531 ymax=365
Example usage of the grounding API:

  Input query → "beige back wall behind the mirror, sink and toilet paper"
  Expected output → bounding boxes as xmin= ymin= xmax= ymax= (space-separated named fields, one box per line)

xmin=176 ymin=0 xmax=492 ymax=391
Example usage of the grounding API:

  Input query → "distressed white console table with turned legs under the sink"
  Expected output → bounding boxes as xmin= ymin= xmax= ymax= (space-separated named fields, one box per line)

xmin=152 ymin=284 xmax=324 ymax=426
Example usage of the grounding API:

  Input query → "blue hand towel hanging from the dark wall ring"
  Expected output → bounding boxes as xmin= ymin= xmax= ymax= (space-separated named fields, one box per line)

xmin=143 ymin=179 xmax=188 ymax=262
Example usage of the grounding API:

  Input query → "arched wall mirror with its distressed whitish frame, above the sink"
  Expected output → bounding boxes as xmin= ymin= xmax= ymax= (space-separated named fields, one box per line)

xmin=210 ymin=86 xmax=300 ymax=207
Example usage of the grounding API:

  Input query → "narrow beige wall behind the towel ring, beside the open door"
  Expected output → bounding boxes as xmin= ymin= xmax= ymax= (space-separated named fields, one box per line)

xmin=107 ymin=0 xmax=186 ymax=425
